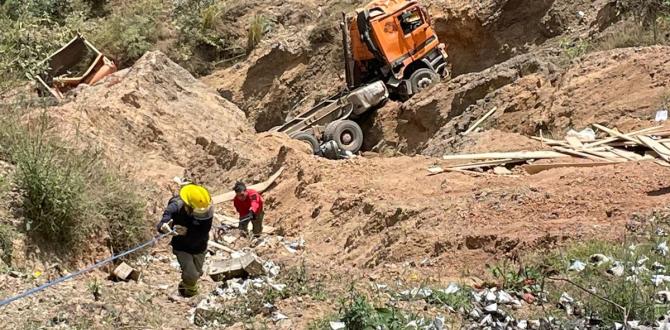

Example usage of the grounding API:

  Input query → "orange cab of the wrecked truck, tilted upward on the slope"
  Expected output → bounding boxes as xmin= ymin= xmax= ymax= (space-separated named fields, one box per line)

xmin=346 ymin=0 xmax=449 ymax=96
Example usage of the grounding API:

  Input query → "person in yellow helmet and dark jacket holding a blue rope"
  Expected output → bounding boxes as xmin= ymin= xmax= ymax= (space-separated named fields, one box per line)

xmin=156 ymin=184 xmax=214 ymax=297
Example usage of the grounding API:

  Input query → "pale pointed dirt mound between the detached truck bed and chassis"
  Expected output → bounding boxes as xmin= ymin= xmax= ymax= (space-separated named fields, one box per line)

xmin=49 ymin=52 xmax=286 ymax=191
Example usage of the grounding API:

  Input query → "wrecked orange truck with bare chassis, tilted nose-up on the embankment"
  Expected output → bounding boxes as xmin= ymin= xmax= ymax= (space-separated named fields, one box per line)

xmin=271 ymin=0 xmax=449 ymax=158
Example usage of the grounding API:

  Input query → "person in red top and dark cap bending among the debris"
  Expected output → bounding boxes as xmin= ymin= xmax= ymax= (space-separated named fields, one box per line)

xmin=233 ymin=181 xmax=265 ymax=238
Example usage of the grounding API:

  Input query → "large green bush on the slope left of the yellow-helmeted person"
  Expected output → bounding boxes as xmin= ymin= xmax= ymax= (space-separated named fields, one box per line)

xmin=0 ymin=109 xmax=149 ymax=255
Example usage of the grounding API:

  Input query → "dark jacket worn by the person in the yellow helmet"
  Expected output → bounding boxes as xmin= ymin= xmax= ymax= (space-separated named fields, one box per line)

xmin=156 ymin=196 xmax=212 ymax=254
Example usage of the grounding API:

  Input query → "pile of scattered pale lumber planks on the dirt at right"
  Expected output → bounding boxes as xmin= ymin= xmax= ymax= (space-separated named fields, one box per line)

xmin=428 ymin=124 xmax=670 ymax=175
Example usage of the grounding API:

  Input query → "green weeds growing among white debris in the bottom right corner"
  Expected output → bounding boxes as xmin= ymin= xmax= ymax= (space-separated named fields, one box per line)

xmin=541 ymin=210 xmax=670 ymax=324
